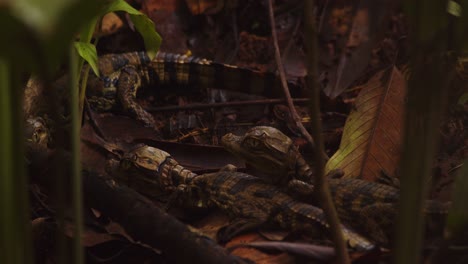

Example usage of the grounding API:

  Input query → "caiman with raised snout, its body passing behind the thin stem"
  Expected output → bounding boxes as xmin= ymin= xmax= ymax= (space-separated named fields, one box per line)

xmin=222 ymin=126 xmax=448 ymax=245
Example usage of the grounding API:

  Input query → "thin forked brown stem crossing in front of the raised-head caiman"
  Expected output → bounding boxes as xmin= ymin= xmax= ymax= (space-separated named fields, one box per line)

xmin=268 ymin=0 xmax=350 ymax=263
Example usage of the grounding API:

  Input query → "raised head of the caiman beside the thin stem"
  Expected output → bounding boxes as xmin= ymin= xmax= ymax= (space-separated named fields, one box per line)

xmin=221 ymin=126 xmax=300 ymax=182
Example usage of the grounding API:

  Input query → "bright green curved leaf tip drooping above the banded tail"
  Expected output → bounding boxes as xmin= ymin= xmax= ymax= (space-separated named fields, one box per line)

xmin=104 ymin=0 xmax=162 ymax=59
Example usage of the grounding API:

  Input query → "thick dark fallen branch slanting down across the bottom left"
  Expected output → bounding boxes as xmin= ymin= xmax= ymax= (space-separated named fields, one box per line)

xmin=27 ymin=145 xmax=247 ymax=263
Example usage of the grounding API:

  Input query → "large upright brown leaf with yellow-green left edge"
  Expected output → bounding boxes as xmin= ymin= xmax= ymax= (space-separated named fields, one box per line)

xmin=325 ymin=67 xmax=406 ymax=181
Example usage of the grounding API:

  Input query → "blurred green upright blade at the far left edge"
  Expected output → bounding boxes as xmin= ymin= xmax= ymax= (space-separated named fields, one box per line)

xmin=0 ymin=59 xmax=32 ymax=264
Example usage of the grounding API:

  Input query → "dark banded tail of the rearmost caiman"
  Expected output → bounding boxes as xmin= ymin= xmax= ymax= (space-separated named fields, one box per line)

xmin=99 ymin=52 xmax=300 ymax=98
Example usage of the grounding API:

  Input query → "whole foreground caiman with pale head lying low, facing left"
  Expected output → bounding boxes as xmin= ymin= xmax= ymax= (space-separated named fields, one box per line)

xmin=111 ymin=146 xmax=373 ymax=250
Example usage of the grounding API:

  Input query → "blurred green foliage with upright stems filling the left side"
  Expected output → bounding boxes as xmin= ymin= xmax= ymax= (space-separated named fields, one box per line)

xmin=0 ymin=0 xmax=161 ymax=264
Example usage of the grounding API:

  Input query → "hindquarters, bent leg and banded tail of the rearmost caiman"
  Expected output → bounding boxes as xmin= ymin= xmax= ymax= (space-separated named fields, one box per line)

xmin=87 ymin=52 xmax=288 ymax=130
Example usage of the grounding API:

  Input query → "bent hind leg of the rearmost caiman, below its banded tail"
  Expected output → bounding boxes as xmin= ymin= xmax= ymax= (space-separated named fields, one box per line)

xmin=117 ymin=65 xmax=158 ymax=131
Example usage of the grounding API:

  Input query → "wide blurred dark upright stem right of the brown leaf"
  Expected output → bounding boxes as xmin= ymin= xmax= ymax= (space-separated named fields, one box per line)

xmin=395 ymin=1 xmax=453 ymax=264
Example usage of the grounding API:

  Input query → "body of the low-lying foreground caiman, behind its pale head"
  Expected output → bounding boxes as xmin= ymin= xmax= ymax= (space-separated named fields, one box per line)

xmin=189 ymin=171 xmax=374 ymax=250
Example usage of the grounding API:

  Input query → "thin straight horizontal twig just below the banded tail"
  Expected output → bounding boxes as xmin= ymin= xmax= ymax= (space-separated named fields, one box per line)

xmin=145 ymin=98 xmax=309 ymax=112
